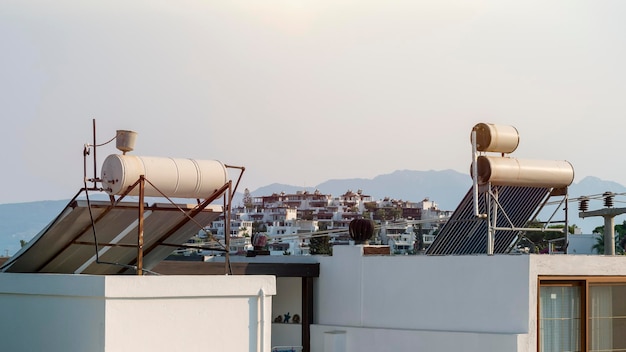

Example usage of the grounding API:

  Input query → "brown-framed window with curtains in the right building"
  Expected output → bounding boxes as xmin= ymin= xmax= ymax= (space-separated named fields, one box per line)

xmin=538 ymin=277 xmax=626 ymax=352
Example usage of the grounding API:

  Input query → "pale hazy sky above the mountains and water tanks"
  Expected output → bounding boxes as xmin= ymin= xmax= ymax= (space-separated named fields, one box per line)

xmin=0 ymin=0 xmax=626 ymax=203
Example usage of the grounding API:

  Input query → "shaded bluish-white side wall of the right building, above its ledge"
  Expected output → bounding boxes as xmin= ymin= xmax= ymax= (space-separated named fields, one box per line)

xmin=315 ymin=246 xmax=529 ymax=334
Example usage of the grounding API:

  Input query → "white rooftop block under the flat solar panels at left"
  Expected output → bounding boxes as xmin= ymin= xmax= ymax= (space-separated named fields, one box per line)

xmin=0 ymin=273 xmax=276 ymax=352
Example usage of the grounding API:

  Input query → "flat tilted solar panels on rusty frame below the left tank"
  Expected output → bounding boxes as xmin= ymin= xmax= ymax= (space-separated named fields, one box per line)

xmin=1 ymin=199 xmax=222 ymax=275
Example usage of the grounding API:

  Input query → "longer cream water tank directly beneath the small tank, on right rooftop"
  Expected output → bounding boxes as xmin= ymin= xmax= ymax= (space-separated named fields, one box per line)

xmin=470 ymin=155 xmax=574 ymax=188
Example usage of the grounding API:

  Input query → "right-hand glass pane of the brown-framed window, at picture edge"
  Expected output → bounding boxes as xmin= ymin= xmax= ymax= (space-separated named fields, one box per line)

xmin=589 ymin=284 xmax=626 ymax=351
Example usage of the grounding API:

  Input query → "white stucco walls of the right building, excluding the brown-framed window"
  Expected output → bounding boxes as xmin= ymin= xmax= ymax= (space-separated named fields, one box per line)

xmin=311 ymin=246 xmax=626 ymax=352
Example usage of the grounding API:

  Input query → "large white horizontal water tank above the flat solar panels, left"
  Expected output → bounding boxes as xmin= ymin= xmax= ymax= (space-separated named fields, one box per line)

xmin=101 ymin=154 xmax=228 ymax=199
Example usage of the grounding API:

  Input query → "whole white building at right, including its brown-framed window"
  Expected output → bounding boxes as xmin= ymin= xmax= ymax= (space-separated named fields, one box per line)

xmin=311 ymin=246 xmax=626 ymax=352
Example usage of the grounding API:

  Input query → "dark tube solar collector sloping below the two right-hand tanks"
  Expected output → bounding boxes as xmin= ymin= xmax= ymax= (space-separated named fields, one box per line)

xmin=426 ymin=186 xmax=551 ymax=255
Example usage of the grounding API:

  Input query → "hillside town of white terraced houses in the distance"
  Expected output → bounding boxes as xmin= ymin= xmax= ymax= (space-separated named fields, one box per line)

xmin=188 ymin=189 xmax=452 ymax=256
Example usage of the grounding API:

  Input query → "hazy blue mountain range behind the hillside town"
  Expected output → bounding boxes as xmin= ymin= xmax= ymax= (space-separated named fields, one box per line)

xmin=0 ymin=170 xmax=626 ymax=255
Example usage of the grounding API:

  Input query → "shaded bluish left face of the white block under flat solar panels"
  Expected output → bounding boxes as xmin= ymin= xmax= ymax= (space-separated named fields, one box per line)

xmin=0 ymin=273 xmax=105 ymax=351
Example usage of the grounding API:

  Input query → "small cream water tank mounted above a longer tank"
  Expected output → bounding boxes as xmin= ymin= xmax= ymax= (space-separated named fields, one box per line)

xmin=472 ymin=123 xmax=519 ymax=153
